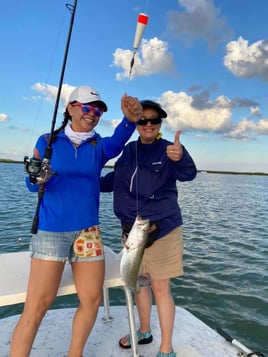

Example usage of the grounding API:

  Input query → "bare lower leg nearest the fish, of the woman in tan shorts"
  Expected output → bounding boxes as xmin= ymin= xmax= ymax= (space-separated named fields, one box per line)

xmin=135 ymin=286 xmax=152 ymax=333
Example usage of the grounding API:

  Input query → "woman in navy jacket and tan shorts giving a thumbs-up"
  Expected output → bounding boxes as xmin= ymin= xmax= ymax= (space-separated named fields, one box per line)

xmin=101 ymin=100 xmax=197 ymax=357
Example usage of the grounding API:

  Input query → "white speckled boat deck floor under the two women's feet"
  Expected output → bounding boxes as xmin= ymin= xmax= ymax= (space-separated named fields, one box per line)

xmin=0 ymin=306 xmax=238 ymax=357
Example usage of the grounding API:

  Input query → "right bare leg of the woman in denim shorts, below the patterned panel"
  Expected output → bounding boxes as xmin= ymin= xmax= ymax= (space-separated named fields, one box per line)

xmin=68 ymin=260 xmax=105 ymax=357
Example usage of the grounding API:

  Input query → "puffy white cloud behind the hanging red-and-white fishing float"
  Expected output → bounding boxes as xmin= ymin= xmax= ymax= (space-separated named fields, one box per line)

xmin=113 ymin=37 xmax=175 ymax=81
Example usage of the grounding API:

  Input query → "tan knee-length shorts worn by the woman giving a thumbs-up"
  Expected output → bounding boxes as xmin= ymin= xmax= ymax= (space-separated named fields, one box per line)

xmin=140 ymin=226 xmax=183 ymax=279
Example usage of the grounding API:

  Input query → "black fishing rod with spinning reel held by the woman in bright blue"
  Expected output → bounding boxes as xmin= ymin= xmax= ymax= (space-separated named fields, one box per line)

xmin=24 ymin=0 xmax=77 ymax=234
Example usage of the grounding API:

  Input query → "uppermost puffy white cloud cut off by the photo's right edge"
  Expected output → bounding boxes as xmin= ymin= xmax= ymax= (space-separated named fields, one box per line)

xmin=224 ymin=37 xmax=268 ymax=81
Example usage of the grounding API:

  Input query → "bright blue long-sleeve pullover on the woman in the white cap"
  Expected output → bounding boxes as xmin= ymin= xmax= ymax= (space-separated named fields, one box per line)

xmin=26 ymin=118 xmax=136 ymax=232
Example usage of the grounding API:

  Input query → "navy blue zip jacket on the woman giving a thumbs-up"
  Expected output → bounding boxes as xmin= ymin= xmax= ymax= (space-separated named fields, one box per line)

xmin=101 ymin=139 xmax=197 ymax=238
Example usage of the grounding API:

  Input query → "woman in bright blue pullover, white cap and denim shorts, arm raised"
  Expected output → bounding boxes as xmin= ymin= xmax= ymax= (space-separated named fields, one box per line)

xmin=10 ymin=86 xmax=142 ymax=357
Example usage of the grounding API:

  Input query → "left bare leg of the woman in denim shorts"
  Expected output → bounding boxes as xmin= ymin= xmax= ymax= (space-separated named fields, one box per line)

xmin=10 ymin=259 xmax=64 ymax=357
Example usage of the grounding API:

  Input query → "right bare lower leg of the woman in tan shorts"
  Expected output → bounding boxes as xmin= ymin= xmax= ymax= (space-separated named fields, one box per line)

xmin=151 ymin=279 xmax=175 ymax=353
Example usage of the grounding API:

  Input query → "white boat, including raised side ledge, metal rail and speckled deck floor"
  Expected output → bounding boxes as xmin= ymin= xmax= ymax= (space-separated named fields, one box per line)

xmin=0 ymin=247 xmax=242 ymax=357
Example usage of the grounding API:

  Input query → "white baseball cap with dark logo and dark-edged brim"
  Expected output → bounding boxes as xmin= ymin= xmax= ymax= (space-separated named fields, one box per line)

xmin=69 ymin=86 xmax=108 ymax=112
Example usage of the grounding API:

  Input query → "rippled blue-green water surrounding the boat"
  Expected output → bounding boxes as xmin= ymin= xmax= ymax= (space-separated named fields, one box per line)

xmin=0 ymin=163 xmax=268 ymax=357
